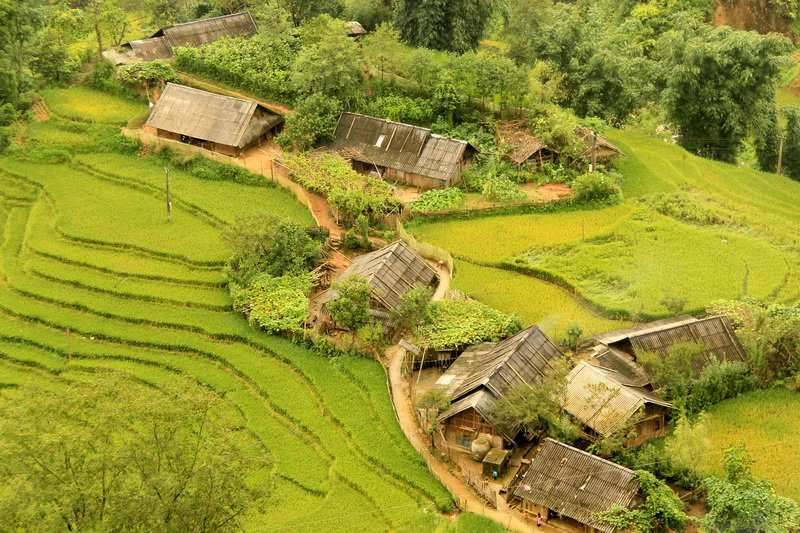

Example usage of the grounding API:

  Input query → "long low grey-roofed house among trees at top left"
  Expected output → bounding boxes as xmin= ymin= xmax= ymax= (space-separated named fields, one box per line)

xmin=103 ymin=11 xmax=258 ymax=64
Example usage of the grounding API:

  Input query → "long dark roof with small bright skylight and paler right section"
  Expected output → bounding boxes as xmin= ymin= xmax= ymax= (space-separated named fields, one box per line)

xmin=332 ymin=113 xmax=477 ymax=180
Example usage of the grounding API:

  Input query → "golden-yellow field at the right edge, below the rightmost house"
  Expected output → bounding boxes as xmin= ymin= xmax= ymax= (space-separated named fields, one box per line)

xmin=705 ymin=389 xmax=800 ymax=501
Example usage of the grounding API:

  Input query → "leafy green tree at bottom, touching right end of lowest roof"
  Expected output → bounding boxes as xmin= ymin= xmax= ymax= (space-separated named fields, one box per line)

xmin=597 ymin=470 xmax=689 ymax=533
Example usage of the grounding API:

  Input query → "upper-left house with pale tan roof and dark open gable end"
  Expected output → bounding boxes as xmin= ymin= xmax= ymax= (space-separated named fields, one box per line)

xmin=146 ymin=83 xmax=284 ymax=156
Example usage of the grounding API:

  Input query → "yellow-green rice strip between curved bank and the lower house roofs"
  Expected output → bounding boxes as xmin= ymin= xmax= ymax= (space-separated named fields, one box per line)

xmin=453 ymin=261 xmax=630 ymax=341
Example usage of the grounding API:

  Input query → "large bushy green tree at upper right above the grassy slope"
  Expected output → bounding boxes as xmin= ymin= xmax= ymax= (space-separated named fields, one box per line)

xmin=660 ymin=23 xmax=791 ymax=163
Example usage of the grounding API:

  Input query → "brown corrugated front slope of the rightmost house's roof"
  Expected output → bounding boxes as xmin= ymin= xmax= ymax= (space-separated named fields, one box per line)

xmin=630 ymin=315 xmax=747 ymax=375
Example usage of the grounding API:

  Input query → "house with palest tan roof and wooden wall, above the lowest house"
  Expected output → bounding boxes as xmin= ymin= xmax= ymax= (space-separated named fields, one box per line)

xmin=564 ymin=362 xmax=675 ymax=445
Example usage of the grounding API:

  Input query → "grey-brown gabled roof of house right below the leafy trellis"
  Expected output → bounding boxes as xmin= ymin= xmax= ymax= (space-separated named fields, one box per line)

xmin=436 ymin=325 xmax=564 ymax=400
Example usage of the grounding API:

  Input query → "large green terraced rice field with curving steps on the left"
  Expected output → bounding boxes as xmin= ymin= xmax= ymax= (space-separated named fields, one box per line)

xmin=0 ymin=89 xmax=449 ymax=531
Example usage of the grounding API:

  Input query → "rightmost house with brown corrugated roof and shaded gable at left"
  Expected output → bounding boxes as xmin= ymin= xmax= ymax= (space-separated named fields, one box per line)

xmin=593 ymin=315 xmax=747 ymax=387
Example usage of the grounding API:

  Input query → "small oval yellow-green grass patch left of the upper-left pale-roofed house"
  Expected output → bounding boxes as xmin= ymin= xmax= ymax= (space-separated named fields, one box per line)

xmin=42 ymin=85 xmax=147 ymax=125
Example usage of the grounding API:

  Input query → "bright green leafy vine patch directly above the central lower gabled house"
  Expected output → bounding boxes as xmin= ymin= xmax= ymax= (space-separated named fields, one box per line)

xmin=417 ymin=299 xmax=522 ymax=348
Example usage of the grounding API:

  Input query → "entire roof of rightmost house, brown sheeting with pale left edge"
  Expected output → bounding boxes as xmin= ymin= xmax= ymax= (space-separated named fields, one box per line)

xmin=595 ymin=315 xmax=747 ymax=375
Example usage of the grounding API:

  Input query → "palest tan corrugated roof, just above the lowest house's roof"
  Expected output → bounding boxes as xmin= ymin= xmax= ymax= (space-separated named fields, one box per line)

xmin=564 ymin=362 xmax=675 ymax=435
